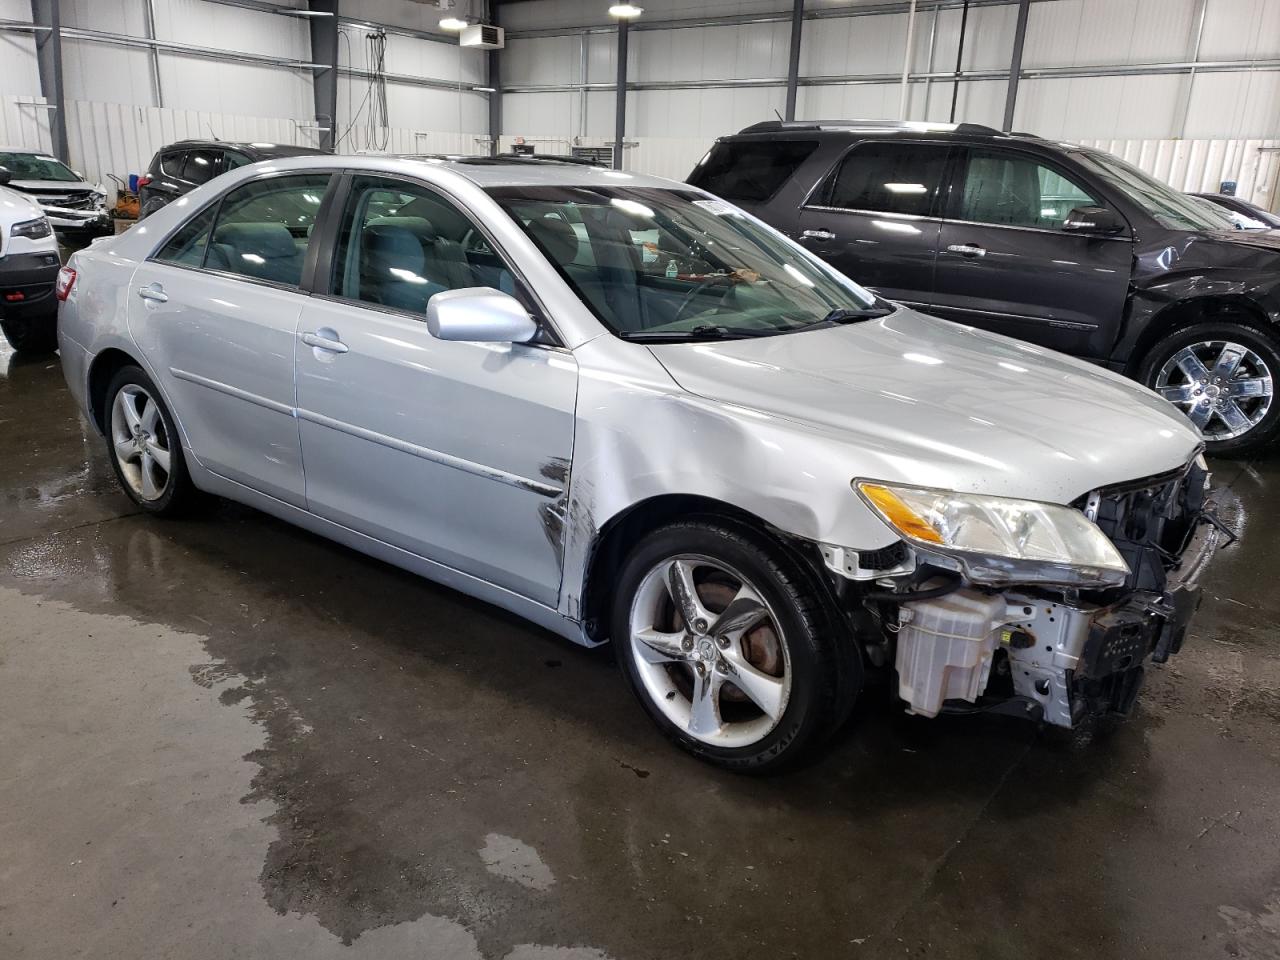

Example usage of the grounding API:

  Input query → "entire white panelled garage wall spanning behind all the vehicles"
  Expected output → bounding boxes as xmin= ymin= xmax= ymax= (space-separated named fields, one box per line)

xmin=0 ymin=0 xmax=1280 ymax=206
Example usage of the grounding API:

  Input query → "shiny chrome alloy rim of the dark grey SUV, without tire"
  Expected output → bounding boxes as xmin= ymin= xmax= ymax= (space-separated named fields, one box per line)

xmin=1152 ymin=340 xmax=1272 ymax=440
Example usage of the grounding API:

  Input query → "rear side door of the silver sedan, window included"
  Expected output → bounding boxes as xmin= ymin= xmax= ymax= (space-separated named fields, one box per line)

xmin=128 ymin=173 xmax=330 ymax=506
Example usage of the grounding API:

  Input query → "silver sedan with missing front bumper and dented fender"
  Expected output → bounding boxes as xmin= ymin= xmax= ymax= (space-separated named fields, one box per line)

xmin=59 ymin=156 xmax=1215 ymax=771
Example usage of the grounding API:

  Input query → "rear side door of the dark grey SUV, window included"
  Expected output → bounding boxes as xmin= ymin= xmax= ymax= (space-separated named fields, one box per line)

xmin=795 ymin=140 xmax=950 ymax=306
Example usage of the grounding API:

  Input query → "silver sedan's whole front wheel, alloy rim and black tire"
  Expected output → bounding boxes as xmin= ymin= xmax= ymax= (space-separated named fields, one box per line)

xmin=612 ymin=521 xmax=860 ymax=772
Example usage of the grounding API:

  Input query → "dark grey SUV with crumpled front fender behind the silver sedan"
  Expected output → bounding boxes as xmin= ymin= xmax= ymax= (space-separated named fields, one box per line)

xmin=689 ymin=120 xmax=1280 ymax=454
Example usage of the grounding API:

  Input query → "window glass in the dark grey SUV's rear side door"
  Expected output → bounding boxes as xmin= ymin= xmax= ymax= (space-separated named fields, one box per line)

xmin=817 ymin=141 xmax=947 ymax=216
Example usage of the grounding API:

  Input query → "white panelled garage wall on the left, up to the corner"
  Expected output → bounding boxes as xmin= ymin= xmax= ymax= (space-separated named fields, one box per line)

xmin=0 ymin=0 xmax=489 ymax=184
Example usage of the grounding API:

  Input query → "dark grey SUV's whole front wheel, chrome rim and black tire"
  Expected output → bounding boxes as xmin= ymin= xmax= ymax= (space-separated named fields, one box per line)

xmin=1139 ymin=321 xmax=1280 ymax=457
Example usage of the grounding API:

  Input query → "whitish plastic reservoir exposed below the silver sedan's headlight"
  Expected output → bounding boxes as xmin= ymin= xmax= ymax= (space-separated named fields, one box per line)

xmin=897 ymin=590 xmax=1009 ymax=717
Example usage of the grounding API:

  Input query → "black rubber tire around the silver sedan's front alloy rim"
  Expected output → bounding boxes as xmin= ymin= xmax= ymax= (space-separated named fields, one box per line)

xmin=611 ymin=518 xmax=863 ymax=773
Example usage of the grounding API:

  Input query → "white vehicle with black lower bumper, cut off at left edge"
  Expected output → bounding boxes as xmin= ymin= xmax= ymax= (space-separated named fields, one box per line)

xmin=0 ymin=173 xmax=59 ymax=352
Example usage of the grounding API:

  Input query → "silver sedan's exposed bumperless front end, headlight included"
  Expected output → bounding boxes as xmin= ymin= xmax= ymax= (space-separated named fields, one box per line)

xmin=823 ymin=457 xmax=1222 ymax=727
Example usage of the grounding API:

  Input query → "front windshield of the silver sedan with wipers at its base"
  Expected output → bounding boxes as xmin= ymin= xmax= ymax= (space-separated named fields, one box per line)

xmin=489 ymin=187 xmax=892 ymax=340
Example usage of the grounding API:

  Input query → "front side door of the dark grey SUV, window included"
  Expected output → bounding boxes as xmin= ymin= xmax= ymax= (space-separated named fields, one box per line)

xmin=932 ymin=146 xmax=1133 ymax=357
